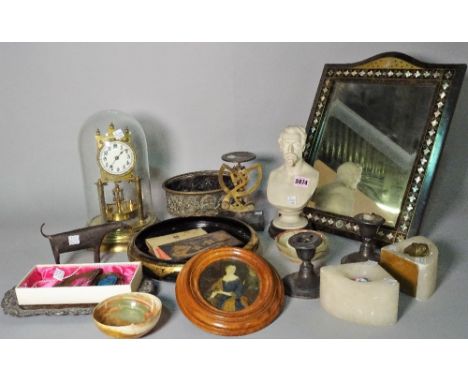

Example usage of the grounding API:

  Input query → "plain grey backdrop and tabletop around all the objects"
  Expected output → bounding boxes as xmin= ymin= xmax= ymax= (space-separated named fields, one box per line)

xmin=0 ymin=43 xmax=468 ymax=338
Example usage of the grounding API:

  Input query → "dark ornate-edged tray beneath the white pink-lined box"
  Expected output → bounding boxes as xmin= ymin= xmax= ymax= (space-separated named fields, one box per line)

xmin=2 ymin=278 xmax=156 ymax=317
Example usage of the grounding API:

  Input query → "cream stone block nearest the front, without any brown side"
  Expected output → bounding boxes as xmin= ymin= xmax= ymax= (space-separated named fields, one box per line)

xmin=320 ymin=261 xmax=399 ymax=326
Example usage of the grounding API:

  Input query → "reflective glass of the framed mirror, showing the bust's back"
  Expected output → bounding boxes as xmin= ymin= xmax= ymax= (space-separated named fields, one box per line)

xmin=313 ymin=81 xmax=436 ymax=227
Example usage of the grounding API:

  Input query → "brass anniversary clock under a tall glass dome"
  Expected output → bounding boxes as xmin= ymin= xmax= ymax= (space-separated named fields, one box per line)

xmin=79 ymin=110 xmax=156 ymax=251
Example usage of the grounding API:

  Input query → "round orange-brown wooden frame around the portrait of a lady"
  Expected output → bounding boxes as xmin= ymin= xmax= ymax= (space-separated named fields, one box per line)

xmin=176 ymin=247 xmax=284 ymax=336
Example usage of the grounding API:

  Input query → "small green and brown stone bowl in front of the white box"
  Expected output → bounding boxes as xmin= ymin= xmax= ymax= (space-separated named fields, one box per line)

xmin=93 ymin=292 xmax=162 ymax=338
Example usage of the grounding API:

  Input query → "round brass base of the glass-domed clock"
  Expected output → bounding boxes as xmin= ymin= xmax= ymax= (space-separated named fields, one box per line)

xmin=89 ymin=216 xmax=156 ymax=253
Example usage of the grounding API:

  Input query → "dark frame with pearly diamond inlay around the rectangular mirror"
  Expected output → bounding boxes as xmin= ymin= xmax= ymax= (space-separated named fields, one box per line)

xmin=303 ymin=52 xmax=466 ymax=245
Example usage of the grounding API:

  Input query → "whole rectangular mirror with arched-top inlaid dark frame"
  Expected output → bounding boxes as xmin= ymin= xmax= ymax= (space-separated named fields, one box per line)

xmin=303 ymin=53 xmax=466 ymax=244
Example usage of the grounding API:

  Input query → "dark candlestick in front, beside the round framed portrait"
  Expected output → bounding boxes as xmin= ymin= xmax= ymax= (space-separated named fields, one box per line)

xmin=283 ymin=232 xmax=322 ymax=298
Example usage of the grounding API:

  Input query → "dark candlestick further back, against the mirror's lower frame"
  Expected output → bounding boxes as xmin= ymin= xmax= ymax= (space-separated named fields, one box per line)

xmin=341 ymin=213 xmax=385 ymax=264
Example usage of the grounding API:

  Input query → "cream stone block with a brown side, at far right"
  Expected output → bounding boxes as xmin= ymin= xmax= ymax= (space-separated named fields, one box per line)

xmin=380 ymin=236 xmax=439 ymax=301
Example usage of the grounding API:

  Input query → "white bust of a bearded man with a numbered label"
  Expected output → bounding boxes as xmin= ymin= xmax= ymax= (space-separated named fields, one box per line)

xmin=267 ymin=126 xmax=319 ymax=229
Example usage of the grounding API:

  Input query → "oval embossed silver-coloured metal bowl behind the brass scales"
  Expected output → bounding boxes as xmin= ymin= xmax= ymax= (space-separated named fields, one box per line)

xmin=162 ymin=171 xmax=231 ymax=216
